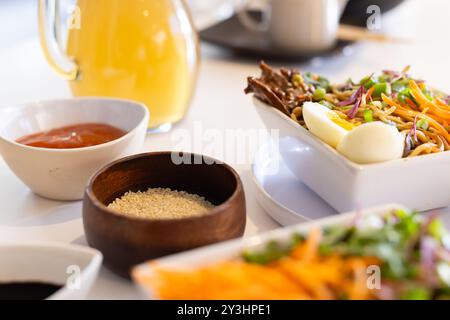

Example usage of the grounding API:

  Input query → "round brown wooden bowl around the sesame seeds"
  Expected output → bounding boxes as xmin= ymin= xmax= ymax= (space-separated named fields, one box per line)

xmin=83 ymin=152 xmax=246 ymax=278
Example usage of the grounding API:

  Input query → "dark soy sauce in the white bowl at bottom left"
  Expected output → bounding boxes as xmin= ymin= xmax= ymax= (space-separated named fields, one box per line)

xmin=0 ymin=282 xmax=62 ymax=300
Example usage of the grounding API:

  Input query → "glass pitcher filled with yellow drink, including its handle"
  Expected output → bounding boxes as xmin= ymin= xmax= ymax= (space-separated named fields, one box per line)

xmin=39 ymin=0 xmax=199 ymax=129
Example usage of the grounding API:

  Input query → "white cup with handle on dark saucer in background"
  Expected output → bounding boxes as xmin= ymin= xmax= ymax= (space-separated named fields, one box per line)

xmin=238 ymin=0 xmax=348 ymax=53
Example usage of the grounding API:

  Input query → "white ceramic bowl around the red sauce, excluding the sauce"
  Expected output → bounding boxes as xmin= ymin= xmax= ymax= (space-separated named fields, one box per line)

xmin=0 ymin=98 xmax=149 ymax=200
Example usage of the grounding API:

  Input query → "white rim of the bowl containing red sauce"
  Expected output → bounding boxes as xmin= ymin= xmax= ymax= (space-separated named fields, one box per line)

xmin=0 ymin=97 xmax=150 ymax=153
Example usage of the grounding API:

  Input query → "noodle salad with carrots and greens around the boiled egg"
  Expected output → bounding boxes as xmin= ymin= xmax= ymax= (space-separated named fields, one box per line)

xmin=245 ymin=62 xmax=450 ymax=157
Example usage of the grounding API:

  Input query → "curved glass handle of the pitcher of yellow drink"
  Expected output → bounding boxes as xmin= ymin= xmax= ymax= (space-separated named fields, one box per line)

xmin=38 ymin=0 xmax=79 ymax=80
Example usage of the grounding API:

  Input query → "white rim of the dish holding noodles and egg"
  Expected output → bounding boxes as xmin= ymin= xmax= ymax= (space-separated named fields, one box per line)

xmin=253 ymin=97 xmax=450 ymax=171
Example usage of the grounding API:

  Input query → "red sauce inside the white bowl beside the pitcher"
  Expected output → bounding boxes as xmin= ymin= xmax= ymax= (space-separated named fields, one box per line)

xmin=16 ymin=123 xmax=126 ymax=149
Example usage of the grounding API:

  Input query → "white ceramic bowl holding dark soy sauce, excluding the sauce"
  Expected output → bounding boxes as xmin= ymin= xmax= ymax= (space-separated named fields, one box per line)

xmin=0 ymin=243 xmax=103 ymax=300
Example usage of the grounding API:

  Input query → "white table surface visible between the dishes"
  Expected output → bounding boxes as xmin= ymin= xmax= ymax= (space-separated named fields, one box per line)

xmin=0 ymin=0 xmax=450 ymax=299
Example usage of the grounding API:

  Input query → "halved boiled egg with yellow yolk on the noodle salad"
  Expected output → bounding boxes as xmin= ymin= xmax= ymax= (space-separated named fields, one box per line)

xmin=303 ymin=102 xmax=405 ymax=164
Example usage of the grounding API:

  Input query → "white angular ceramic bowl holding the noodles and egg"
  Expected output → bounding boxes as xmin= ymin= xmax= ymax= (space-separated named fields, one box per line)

xmin=253 ymin=98 xmax=450 ymax=212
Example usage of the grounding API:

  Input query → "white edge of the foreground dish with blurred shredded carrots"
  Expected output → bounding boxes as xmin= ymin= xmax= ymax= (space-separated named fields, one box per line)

xmin=133 ymin=204 xmax=405 ymax=299
